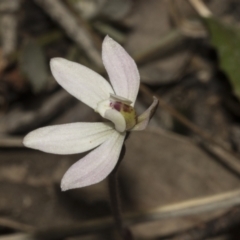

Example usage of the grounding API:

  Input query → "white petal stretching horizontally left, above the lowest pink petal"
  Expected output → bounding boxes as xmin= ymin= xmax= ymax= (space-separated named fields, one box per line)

xmin=23 ymin=123 xmax=115 ymax=154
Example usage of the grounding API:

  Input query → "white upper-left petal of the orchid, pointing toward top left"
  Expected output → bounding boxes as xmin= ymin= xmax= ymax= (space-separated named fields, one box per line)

xmin=50 ymin=58 xmax=113 ymax=109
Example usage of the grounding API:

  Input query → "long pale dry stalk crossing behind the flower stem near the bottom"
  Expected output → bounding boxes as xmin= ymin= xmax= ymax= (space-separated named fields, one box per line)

xmin=0 ymin=190 xmax=240 ymax=240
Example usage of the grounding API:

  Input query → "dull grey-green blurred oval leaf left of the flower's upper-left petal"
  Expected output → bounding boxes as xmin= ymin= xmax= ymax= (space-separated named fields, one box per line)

xmin=20 ymin=40 xmax=48 ymax=93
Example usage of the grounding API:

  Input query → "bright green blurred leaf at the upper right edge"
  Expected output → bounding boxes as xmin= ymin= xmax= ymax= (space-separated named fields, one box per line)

xmin=203 ymin=17 xmax=240 ymax=97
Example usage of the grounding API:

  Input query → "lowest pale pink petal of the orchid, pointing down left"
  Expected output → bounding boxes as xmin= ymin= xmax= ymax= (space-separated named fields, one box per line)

xmin=61 ymin=131 xmax=125 ymax=191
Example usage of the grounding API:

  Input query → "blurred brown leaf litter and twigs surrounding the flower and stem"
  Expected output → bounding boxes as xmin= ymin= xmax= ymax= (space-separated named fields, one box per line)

xmin=0 ymin=0 xmax=240 ymax=240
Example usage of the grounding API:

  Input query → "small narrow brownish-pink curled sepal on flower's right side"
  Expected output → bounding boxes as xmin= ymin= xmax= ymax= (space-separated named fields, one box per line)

xmin=131 ymin=97 xmax=158 ymax=131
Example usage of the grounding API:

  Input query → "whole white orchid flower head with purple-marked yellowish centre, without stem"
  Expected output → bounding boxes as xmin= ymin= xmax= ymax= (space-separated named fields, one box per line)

xmin=23 ymin=36 xmax=158 ymax=190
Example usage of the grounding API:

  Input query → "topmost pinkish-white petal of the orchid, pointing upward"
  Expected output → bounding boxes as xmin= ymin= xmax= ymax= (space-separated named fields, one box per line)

xmin=102 ymin=36 xmax=140 ymax=105
